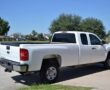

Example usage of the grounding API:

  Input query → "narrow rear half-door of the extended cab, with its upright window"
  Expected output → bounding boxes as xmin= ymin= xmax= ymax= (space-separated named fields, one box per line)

xmin=79 ymin=33 xmax=92 ymax=64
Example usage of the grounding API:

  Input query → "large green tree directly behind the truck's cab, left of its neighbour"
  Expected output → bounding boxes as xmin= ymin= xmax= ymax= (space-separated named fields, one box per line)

xmin=49 ymin=14 xmax=81 ymax=33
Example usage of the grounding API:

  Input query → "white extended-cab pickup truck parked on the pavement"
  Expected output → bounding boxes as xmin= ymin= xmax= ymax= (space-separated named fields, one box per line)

xmin=0 ymin=31 xmax=110 ymax=83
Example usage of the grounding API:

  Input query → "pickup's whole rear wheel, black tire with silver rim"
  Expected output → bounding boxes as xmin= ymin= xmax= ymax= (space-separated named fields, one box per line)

xmin=40 ymin=61 xmax=59 ymax=83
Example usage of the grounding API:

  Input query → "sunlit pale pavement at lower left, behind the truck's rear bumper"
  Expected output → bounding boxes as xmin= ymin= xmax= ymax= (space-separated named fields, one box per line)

xmin=0 ymin=66 xmax=22 ymax=90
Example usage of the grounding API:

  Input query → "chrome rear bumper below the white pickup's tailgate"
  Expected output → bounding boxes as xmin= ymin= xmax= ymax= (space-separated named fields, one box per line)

xmin=0 ymin=58 xmax=28 ymax=72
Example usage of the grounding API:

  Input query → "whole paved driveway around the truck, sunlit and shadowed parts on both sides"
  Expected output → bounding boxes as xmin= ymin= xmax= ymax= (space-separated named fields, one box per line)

xmin=0 ymin=65 xmax=110 ymax=90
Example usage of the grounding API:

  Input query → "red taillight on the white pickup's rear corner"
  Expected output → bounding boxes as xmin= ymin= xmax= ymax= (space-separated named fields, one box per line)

xmin=20 ymin=49 xmax=29 ymax=61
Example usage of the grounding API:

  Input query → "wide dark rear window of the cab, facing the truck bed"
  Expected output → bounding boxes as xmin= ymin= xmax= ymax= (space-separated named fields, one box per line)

xmin=52 ymin=33 xmax=76 ymax=43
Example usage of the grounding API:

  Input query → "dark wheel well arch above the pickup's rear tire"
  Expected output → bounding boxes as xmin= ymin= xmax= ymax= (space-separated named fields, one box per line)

xmin=41 ymin=55 xmax=61 ymax=67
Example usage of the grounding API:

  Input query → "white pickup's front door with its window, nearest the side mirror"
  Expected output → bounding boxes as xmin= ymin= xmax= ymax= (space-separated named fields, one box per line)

xmin=89 ymin=34 xmax=106 ymax=62
